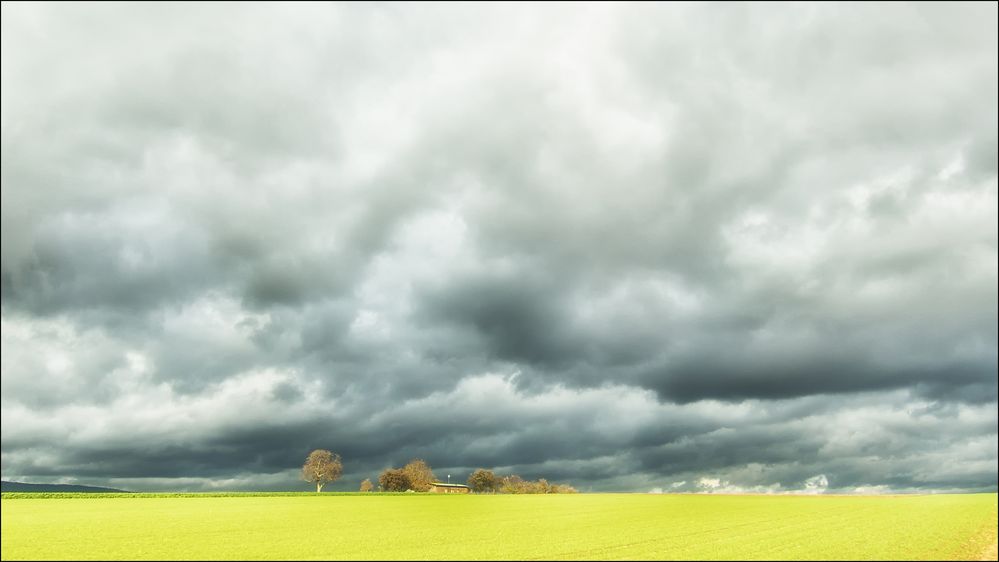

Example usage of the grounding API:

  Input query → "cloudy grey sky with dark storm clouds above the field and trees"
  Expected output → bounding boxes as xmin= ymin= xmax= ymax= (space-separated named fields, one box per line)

xmin=0 ymin=2 xmax=999 ymax=493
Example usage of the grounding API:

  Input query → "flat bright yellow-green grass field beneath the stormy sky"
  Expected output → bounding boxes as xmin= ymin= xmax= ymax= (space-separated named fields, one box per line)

xmin=0 ymin=494 xmax=996 ymax=560
